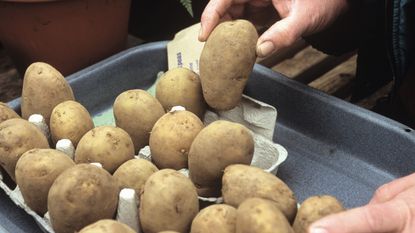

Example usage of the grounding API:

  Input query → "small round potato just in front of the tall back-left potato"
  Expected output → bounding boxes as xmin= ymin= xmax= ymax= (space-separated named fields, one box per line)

xmin=50 ymin=100 xmax=94 ymax=147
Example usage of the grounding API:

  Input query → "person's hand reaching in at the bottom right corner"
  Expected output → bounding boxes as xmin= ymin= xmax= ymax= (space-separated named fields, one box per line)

xmin=309 ymin=173 xmax=415 ymax=233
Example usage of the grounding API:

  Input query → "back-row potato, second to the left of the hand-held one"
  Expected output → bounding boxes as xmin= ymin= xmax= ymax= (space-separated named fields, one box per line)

xmin=113 ymin=89 xmax=165 ymax=153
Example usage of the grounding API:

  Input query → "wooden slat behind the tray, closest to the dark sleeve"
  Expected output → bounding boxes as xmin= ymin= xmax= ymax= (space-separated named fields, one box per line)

xmin=309 ymin=55 xmax=357 ymax=97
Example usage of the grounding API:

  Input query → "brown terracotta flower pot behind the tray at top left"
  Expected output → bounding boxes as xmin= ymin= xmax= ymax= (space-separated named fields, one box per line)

xmin=0 ymin=0 xmax=131 ymax=75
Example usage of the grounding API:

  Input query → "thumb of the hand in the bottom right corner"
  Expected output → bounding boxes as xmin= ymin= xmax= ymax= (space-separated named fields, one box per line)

xmin=309 ymin=201 xmax=408 ymax=233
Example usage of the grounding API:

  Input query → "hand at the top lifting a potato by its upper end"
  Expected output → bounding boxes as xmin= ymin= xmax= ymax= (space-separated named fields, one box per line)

xmin=199 ymin=0 xmax=347 ymax=57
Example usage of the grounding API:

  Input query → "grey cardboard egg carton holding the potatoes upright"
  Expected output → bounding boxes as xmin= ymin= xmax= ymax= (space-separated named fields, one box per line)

xmin=0 ymin=96 xmax=288 ymax=233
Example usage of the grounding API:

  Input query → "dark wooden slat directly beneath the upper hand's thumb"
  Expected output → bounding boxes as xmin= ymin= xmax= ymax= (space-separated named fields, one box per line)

xmin=256 ymin=40 xmax=307 ymax=68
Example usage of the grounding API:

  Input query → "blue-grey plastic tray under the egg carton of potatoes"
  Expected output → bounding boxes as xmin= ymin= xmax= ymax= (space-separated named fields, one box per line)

xmin=0 ymin=42 xmax=415 ymax=233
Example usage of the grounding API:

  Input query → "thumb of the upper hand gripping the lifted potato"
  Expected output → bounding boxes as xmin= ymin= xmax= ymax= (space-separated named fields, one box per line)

xmin=257 ymin=15 xmax=306 ymax=57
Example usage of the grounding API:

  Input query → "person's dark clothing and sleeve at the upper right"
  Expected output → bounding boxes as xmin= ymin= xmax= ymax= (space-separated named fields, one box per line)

xmin=305 ymin=0 xmax=415 ymax=102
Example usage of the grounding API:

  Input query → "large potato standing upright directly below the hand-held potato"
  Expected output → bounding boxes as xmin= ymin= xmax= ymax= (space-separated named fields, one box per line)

xmin=189 ymin=120 xmax=254 ymax=193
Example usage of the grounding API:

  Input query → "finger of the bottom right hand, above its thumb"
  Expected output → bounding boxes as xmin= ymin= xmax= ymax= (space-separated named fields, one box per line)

xmin=369 ymin=173 xmax=415 ymax=204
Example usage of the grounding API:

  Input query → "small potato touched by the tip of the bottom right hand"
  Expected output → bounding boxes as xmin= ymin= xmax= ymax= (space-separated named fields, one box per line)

xmin=293 ymin=195 xmax=344 ymax=233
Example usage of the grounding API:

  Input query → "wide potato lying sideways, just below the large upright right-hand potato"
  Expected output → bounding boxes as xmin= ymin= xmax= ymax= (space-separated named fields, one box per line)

xmin=222 ymin=164 xmax=297 ymax=222
